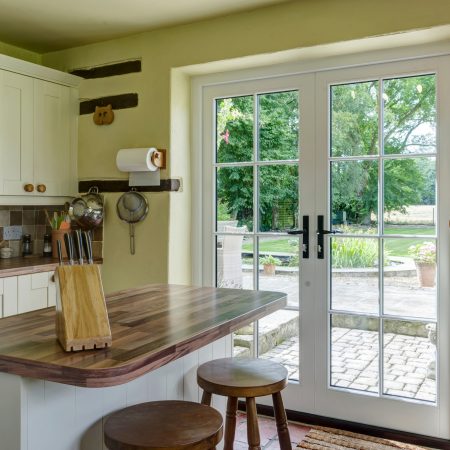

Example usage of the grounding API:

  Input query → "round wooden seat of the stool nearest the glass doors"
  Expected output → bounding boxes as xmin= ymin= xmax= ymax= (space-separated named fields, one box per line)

xmin=197 ymin=358 xmax=288 ymax=397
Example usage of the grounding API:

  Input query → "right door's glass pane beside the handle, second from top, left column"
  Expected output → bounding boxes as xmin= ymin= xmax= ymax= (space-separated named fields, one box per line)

xmin=331 ymin=160 xmax=378 ymax=234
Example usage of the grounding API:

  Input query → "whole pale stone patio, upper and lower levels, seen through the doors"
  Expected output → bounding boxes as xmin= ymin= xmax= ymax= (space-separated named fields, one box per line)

xmin=236 ymin=272 xmax=436 ymax=402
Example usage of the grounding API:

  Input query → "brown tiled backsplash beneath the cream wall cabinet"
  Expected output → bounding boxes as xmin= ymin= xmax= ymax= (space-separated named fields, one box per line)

xmin=0 ymin=205 xmax=103 ymax=258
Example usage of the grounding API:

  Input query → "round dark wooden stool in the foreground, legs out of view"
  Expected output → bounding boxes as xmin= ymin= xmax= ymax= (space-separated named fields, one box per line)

xmin=104 ymin=400 xmax=223 ymax=450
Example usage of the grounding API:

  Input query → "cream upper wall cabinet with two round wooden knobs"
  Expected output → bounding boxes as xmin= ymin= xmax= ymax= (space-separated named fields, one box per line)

xmin=0 ymin=58 xmax=78 ymax=204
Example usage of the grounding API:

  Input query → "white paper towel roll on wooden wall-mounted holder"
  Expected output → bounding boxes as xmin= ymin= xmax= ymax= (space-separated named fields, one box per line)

xmin=116 ymin=147 xmax=166 ymax=186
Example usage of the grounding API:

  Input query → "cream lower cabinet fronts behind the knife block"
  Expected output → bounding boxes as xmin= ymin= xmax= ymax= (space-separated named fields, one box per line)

xmin=0 ymin=271 xmax=56 ymax=317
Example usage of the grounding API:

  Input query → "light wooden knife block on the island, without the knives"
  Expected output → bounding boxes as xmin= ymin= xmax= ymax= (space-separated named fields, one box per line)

xmin=55 ymin=264 xmax=112 ymax=352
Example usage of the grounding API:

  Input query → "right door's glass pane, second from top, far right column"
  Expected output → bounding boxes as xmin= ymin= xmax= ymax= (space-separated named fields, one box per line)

xmin=384 ymin=157 xmax=436 ymax=235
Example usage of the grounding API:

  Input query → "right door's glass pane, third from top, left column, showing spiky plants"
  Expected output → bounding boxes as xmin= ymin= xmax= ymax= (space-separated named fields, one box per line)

xmin=330 ymin=237 xmax=379 ymax=314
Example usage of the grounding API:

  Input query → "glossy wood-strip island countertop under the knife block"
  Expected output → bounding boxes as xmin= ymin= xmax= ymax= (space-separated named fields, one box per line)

xmin=0 ymin=285 xmax=287 ymax=387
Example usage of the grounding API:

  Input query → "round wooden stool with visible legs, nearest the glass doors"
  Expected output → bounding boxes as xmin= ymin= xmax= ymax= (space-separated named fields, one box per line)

xmin=197 ymin=358 xmax=292 ymax=450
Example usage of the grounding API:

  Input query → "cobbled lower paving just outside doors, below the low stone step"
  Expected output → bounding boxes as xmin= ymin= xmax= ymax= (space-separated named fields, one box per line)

xmin=261 ymin=328 xmax=436 ymax=402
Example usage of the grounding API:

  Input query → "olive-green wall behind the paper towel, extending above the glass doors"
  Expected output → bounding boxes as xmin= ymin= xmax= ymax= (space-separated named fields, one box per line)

xmin=37 ymin=0 xmax=450 ymax=291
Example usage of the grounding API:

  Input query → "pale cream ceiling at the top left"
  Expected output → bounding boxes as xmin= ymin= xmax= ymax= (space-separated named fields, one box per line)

xmin=0 ymin=0 xmax=286 ymax=53
